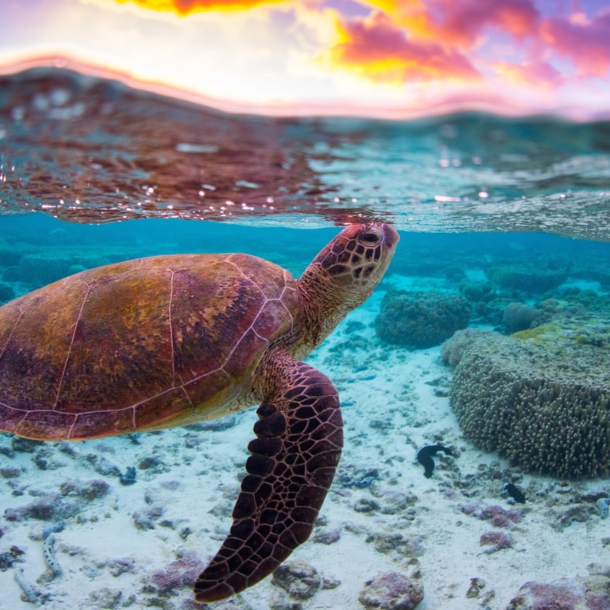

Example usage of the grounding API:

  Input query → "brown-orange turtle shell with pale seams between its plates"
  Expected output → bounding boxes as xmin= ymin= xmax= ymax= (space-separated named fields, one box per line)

xmin=0 ymin=254 xmax=299 ymax=440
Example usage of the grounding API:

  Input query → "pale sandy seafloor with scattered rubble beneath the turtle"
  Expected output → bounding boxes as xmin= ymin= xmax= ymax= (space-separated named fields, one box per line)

xmin=0 ymin=276 xmax=610 ymax=610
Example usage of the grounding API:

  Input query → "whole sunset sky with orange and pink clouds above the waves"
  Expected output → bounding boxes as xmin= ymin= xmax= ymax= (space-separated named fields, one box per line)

xmin=0 ymin=0 xmax=610 ymax=119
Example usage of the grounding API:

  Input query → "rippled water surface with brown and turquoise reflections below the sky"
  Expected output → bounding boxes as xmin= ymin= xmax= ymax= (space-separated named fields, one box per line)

xmin=0 ymin=69 xmax=610 ymax=240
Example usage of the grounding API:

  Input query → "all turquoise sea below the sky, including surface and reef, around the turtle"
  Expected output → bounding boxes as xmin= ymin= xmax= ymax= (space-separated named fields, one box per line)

xmin=0 ymin=70 xmax=610 ymax=610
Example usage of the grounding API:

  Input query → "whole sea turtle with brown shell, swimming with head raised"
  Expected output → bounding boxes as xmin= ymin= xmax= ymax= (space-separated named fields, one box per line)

xmin=0 ymin=223 xmax=399 ymax=602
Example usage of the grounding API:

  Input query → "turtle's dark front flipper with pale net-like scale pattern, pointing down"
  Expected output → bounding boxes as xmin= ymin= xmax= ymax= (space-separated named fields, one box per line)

xmin=195 ymin=357 xmax=343 ymax=602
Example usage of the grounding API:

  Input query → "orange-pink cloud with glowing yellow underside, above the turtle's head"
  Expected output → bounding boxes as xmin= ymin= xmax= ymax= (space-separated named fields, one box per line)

xmin=325 ymin=12 xmax=480 ymax=84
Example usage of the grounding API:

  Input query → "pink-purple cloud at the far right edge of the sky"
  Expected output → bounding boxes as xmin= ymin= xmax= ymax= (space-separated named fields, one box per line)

xmin=540 ymin=10 xmax=610 ymax=78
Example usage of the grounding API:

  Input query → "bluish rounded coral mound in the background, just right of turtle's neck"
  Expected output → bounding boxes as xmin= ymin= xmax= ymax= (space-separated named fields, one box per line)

xmin=375 ymin=290 xmax=470 ymax=348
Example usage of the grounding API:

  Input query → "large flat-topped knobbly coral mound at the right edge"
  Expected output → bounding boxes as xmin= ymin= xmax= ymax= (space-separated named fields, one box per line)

xmin=450 ymin=334 xmax=610 ymax=477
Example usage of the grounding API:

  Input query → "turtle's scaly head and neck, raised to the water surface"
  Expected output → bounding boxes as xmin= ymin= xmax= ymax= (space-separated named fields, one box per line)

xmin=299 ymin=222 xmax=400 ymax=345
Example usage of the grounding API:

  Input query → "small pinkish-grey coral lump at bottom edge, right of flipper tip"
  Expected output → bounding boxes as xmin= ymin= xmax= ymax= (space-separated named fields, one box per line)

xmin=358 ymin=572 xmax=424 ymax=610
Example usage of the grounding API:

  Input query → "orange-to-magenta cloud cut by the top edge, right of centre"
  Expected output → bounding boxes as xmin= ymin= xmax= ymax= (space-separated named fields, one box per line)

xmin=356 ymin=0 xmax=539 ymax=48
